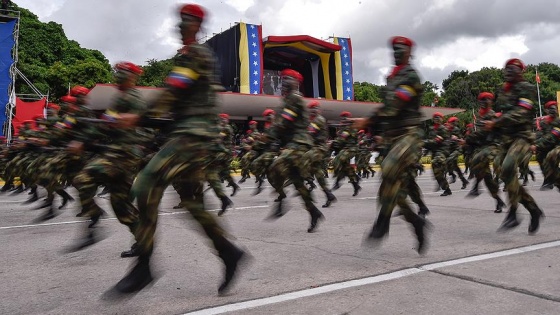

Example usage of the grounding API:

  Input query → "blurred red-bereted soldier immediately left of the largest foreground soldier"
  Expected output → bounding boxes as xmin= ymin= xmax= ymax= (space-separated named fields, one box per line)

xmin=68 ymin=62 xmax=146 ymax=257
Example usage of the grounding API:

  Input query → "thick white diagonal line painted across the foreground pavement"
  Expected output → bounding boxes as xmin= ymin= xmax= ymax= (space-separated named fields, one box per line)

xmin=183 ymin=241 xmax=560 ymax=315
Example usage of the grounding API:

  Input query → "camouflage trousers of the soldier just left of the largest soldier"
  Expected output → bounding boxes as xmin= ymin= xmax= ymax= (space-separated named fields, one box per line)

xmin=73 ymin=155 xmax=140 ymax=234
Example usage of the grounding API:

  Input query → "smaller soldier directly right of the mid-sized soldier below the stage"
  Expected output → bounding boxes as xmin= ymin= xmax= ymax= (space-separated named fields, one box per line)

xmin=303 ymin=101 xmax=336 ymax=208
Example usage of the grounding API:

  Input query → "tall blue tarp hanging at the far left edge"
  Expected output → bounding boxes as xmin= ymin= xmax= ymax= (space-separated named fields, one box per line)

xmin=0 ymin=20 xmax=17 ymax=134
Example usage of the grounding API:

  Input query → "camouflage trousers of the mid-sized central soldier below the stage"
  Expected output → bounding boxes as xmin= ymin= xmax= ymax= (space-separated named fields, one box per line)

xmin=268 ymin=146 xmax=315 ymax=211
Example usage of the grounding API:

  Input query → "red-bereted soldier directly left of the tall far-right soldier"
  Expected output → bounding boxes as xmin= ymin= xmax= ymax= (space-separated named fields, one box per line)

xmin=465 ymin=92 xmax=505 ymax=213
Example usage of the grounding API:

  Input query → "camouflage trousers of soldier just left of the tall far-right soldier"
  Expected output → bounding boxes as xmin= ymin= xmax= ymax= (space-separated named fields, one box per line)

xmin=470 ymin=145 xmax=500 ymax=199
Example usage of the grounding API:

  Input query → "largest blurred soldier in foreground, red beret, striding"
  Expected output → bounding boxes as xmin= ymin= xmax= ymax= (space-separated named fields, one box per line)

xmin=115 ymin=4 xmax=245 ymax=293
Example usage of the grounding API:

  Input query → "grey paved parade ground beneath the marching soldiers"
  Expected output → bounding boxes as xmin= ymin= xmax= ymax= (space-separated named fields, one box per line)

xmin=0 ymin=166 xmax=560 ymax=315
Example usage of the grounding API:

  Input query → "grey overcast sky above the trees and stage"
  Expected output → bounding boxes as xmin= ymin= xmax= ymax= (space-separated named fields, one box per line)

xmin=12 ymin=0 xmax=560 ymax=87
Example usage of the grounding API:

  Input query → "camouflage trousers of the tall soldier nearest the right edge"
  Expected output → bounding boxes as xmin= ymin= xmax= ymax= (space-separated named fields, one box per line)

xmin=500 ymin=138 xmax=538 ymax=213
